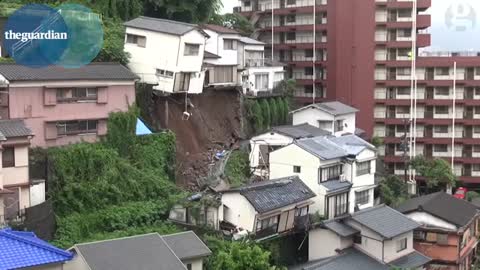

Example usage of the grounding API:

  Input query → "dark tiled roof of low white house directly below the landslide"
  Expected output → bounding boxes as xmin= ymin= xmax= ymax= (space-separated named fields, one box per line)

xmin=231 ymin=176 xmax=315 ymax=213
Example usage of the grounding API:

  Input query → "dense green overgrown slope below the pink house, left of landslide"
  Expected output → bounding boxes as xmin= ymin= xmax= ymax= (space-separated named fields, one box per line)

xmin=48 ymin=108 xmax=185 ymax=247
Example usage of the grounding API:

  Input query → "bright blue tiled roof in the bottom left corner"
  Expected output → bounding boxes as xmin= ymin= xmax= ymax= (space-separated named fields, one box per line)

xmin=0 ymin=229 xmax=73 ymax=270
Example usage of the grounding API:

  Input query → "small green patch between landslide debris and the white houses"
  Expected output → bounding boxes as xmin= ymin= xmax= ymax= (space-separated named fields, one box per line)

xmin=225 ymin=150 xmax=251 ymax=187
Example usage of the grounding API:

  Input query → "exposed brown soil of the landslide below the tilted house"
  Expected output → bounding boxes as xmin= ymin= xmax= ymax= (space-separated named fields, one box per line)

xmin=155 ymin=90 xmax=242 ymax=191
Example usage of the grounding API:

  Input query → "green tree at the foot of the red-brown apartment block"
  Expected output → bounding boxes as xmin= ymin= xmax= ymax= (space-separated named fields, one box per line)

xmin=411 ymin=156 xmax=457 ymax=192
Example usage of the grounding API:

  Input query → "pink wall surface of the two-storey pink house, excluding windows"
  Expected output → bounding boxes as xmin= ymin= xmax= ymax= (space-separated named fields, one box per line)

xmin=9 ymin=81 xmax=135 ymax=147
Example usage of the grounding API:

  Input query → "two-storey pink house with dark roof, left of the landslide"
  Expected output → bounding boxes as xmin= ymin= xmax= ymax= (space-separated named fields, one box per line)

xmin=0 ymin=63 xmax=137 ymax=147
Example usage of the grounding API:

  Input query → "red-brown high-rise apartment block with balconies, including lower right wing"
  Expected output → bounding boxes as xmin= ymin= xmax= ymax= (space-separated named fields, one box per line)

xmin=235 ymin=0 xmax=480 ymax=186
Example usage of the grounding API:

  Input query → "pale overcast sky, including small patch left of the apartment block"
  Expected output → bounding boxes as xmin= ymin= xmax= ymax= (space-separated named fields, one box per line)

xmin=222 ymin=0 xmax=480 ymax=51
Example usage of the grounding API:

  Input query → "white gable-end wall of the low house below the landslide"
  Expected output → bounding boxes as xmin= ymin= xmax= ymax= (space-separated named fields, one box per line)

xmin=222 ymin=192 xmax=257 ymax=232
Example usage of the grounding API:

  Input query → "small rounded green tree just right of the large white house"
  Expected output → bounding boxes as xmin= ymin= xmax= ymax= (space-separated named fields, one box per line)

xmin=379 ymin=175 xmax=409 ymax=207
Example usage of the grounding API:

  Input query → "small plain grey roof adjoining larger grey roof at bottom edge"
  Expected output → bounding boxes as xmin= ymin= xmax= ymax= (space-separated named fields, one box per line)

xmin=163 ymin=231 xmax=212 ymax=260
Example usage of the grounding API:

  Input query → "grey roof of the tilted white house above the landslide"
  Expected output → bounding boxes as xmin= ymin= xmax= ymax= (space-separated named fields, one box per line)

xmin=124 ymin=16 xmax=203 ymax=36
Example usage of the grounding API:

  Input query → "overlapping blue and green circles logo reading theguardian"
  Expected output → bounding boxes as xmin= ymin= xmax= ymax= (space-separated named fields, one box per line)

xmin=3 ymin=4 xmax=103 ymax=68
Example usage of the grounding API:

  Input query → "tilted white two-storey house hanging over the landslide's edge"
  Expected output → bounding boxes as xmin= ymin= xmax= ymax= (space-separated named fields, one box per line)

xmin=124 ymin=16 xmax=209 ymax=94
